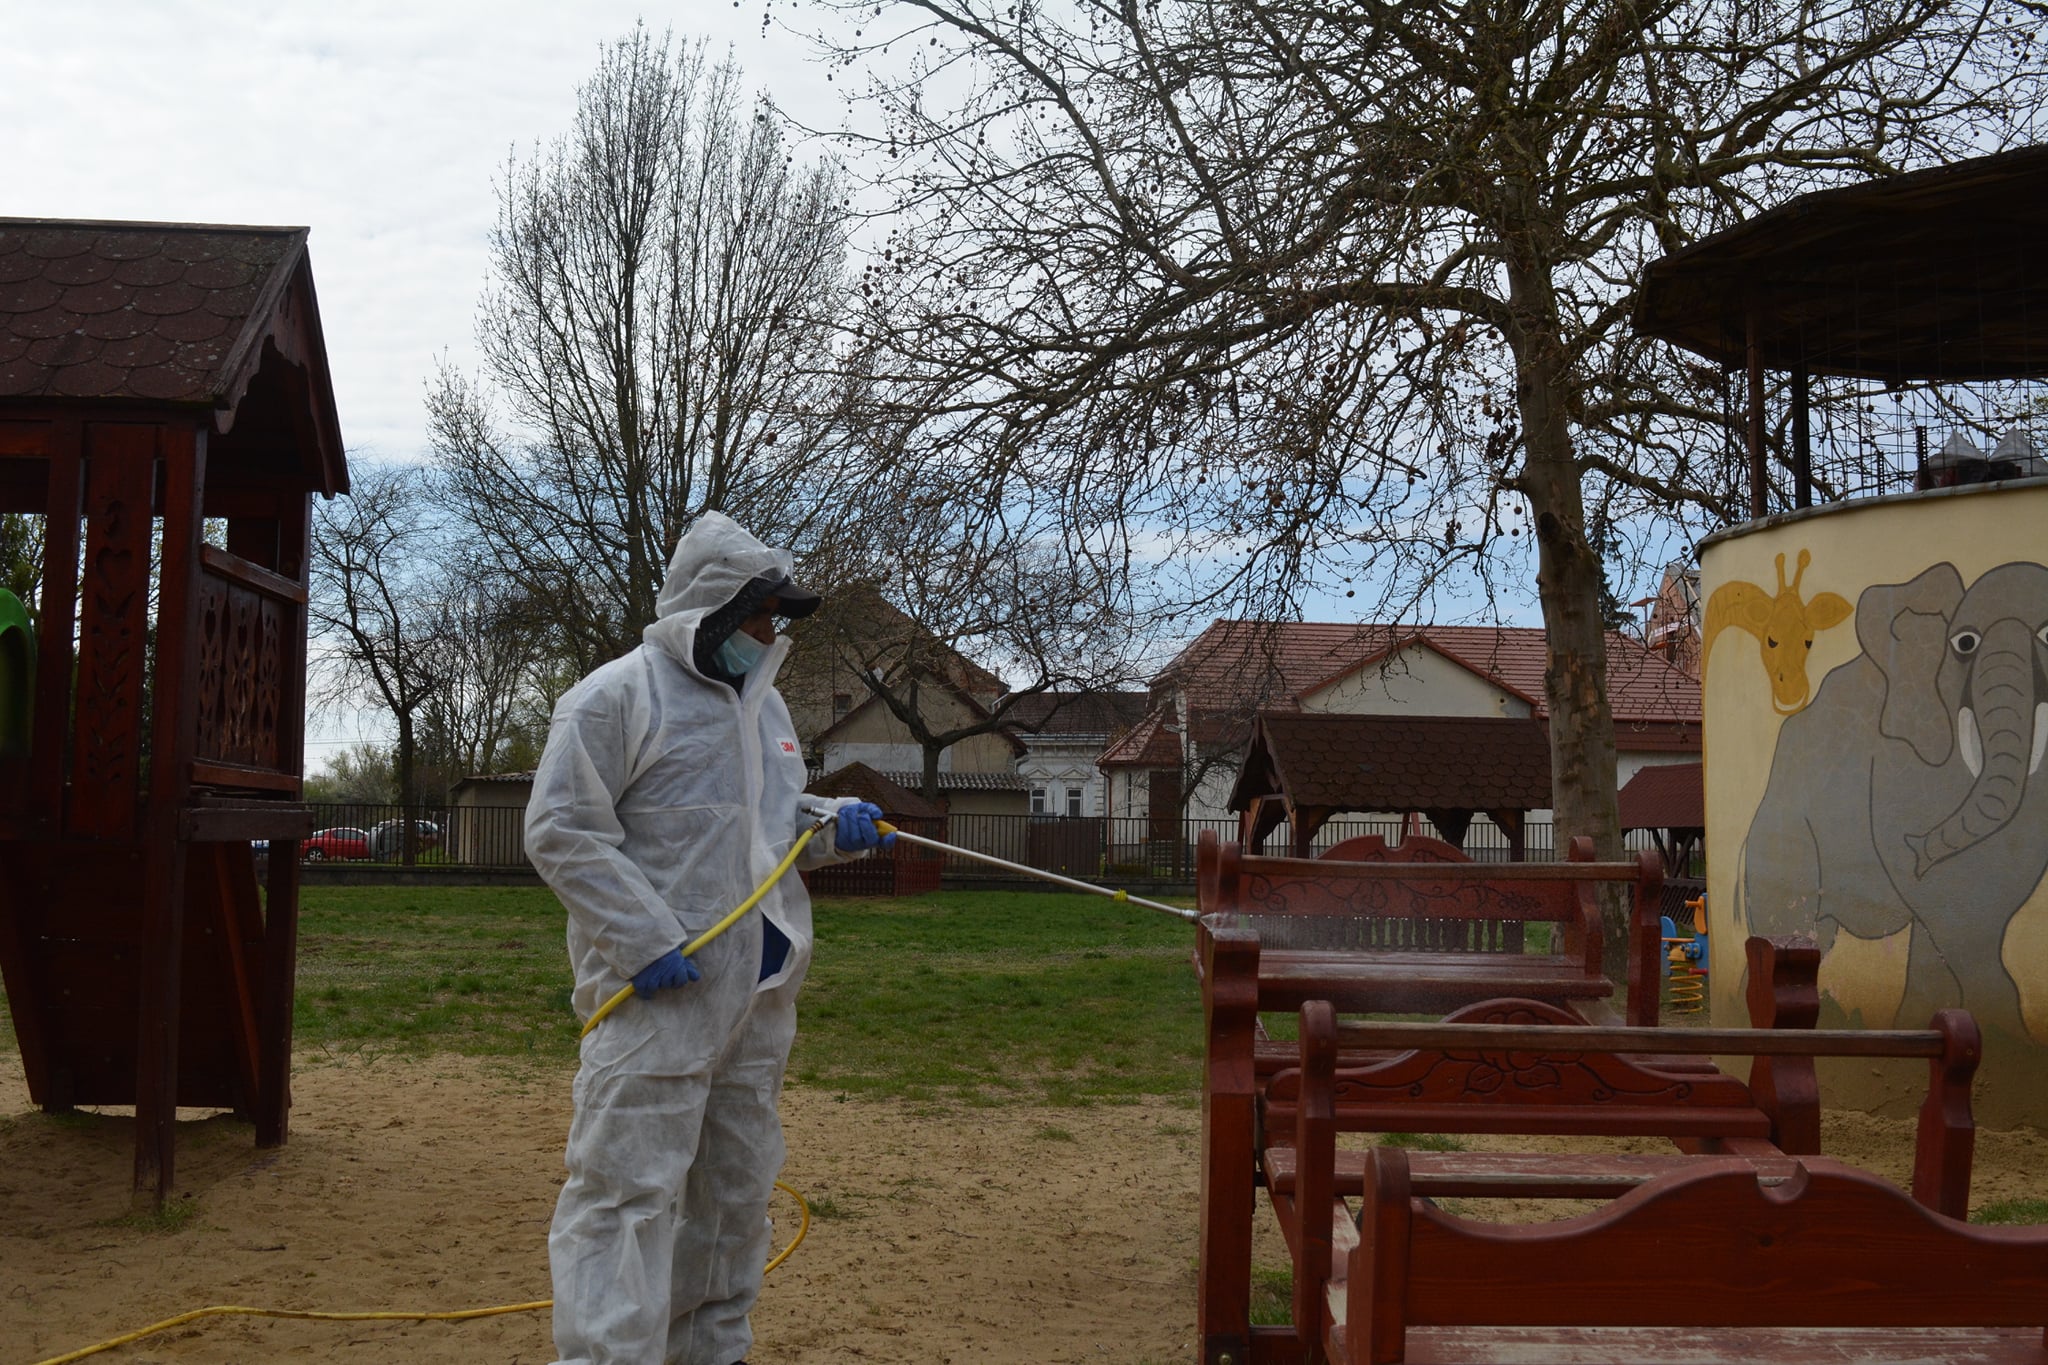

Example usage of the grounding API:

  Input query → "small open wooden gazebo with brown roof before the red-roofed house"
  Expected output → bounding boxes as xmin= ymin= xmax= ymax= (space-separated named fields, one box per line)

xmin=1231 ymin=710 xmax=1550 ymax=862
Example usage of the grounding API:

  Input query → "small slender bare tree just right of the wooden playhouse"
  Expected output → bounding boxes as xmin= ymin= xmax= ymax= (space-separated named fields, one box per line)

xmin=309 ymin=463 xmax=449 ymax=864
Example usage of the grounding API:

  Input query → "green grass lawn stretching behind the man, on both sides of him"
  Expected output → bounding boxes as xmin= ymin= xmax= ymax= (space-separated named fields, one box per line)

xmin=235 ymin=886 xmax=1202 ymax=1103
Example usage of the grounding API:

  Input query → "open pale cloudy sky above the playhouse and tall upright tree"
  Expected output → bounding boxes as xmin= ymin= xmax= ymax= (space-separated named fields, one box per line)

xmin=0 ymin=0 xmax=838 ymax=458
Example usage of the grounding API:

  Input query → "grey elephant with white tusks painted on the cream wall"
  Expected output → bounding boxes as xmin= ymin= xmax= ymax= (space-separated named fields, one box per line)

xmin=1743 ymin=563 xmax=2048 ymax=1038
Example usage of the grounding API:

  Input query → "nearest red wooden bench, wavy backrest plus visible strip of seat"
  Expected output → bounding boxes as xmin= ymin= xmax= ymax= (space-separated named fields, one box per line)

xmin=1335 ymin=1148 xmax=2048 ymax=1365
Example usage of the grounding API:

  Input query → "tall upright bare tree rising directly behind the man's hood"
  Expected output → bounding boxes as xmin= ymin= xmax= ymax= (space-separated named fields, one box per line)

xmin=428 ymin=29 xmax=864 ymax=671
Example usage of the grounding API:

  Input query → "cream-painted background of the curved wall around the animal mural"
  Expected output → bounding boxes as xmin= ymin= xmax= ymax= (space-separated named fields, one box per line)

xmin=1702 ymin=481 xmax=2048 ymax=1121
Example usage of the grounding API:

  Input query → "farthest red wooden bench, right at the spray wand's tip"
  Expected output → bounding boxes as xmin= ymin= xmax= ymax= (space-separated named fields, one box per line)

xmin=1196 ymin=831 xmax=1663 ymax=1025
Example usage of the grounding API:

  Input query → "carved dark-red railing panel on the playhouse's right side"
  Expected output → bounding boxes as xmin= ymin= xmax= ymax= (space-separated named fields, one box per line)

xmin=193 ymin=544 xmax=305 ymax=794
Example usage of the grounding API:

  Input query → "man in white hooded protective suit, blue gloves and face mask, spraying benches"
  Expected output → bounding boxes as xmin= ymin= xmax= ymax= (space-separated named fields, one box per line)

xmin=526 ymin=514 xmax=883 ymax=1365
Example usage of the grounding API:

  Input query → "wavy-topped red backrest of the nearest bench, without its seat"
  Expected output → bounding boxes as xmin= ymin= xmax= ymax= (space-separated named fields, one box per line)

xmin=1346 ymin=1148 xmax=2048 ymax=1365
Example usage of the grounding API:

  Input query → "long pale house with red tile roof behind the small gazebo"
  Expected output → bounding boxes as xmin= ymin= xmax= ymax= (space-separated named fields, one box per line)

xmin=1098 ymin=620 xmax=1702 ymax=827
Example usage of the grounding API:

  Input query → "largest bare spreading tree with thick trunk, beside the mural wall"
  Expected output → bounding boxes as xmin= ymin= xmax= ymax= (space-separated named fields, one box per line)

xmin=817 ymin=0 xmax=2048 ymax=965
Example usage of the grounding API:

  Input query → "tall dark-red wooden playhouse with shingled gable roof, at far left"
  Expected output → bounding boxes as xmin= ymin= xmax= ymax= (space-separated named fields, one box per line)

xmin=0 ymin=219 xmax=348 ymax=1199
